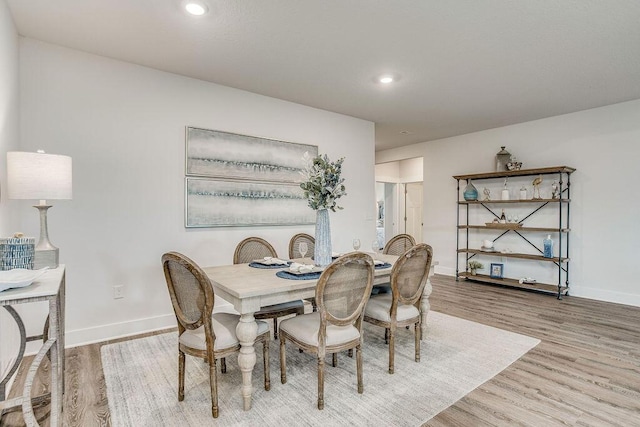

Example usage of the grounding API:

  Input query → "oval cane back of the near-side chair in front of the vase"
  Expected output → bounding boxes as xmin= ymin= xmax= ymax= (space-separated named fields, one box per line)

xmin=316 ymin=252 xmax=374 ymax=335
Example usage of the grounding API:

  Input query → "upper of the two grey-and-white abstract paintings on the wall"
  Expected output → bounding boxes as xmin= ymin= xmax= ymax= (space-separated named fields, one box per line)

xmin=186 ymin=127 xmax=318 ymax=182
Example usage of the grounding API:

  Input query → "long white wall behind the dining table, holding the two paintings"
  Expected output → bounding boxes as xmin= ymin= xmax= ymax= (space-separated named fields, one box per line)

xmin=13 ymin=39 xmax=375 ymax=345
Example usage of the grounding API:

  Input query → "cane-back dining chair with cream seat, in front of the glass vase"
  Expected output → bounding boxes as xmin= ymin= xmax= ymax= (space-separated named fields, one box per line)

xmin=280 ymin=252 xmax=374 ymax=409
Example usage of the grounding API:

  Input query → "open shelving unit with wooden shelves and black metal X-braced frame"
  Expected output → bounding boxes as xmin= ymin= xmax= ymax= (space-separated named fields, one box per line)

xmin=453 ymin=166 xmax=575 ymax=299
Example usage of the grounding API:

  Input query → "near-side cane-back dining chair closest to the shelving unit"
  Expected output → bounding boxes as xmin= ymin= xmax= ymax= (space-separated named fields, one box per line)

xmin=364 ymin=243 xmax=433 ymax=374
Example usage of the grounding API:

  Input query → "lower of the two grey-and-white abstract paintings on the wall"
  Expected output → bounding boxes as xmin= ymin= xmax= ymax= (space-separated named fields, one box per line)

xmin=185 ymin=177 xmax=315 ymax=228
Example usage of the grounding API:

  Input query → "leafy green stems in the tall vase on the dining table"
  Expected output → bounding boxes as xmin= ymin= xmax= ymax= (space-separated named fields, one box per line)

xmin=300 ymin=153 xmax=347 ymax=212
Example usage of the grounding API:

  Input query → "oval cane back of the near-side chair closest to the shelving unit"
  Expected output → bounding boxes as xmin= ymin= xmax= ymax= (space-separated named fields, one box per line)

xmin=391 ymin=243 xmax=433 ymax=311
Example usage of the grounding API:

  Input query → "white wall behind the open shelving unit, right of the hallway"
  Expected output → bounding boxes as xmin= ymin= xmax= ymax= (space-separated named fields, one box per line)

xmin=376 ymin=100 xmax=640 ymax=306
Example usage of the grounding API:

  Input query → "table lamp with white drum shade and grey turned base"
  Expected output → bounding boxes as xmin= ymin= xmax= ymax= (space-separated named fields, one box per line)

xmin=7 ymin=150 xmax=72 ymax=269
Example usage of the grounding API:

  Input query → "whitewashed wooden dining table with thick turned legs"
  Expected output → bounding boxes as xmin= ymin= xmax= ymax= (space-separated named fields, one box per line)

xmin=203 ymin=254 xmax=432 ymax=411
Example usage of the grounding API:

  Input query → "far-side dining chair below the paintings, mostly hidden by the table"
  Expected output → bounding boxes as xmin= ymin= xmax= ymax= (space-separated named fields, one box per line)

xmin=233 ymin=237 xmax=304 ymax=339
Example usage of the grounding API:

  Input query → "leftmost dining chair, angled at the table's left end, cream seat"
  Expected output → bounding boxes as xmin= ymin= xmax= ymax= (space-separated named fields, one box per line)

xmin=162 ymin=252 xmax=271 ymax=418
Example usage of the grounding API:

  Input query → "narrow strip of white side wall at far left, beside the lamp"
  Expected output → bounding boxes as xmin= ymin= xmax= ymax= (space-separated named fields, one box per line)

xmin=0 ymin=0 xmax=20 ymax=388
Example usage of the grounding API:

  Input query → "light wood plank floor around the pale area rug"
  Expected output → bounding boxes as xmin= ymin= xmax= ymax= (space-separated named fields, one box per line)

xmin=0 ymin=276 xmax=640 ymax=427
